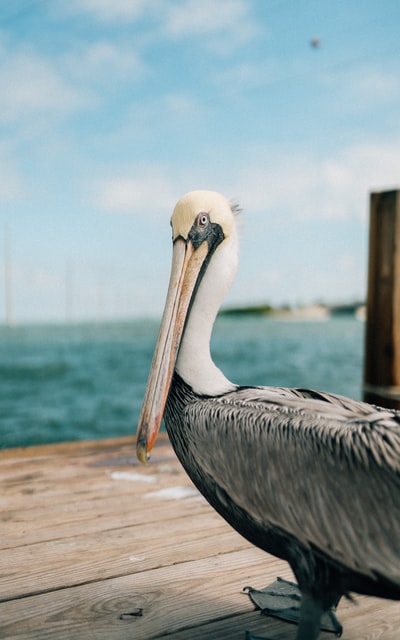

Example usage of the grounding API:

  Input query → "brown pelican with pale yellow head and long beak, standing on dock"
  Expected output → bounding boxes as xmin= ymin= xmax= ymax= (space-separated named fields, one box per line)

xmin=137 ymin=191 xmax=400 ymax=640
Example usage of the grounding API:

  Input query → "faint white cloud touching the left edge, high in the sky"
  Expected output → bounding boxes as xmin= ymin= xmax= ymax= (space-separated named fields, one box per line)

xmin=0 ymin=40 xmax=146 ymax=125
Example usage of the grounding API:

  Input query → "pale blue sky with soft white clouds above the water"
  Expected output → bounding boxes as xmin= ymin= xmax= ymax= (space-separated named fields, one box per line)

xmin=0 ymin=0 xmax=400 ymax=322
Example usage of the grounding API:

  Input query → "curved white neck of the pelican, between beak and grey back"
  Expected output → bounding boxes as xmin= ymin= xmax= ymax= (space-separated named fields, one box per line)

xmin=175 ymin=231 xmax=239 ymax=396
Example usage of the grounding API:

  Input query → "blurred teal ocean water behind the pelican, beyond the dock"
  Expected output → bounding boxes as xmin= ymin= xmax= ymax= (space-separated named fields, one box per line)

xmin=0 ymin=316 xmax=364 ymax=448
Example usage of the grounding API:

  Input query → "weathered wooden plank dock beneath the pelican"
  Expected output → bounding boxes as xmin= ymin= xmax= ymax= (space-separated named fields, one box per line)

xmin=0 ymin=437 xmax=400 ymax=640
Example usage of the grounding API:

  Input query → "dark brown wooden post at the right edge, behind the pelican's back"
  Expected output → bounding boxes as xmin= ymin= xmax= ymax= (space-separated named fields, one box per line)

xmin=364 ymin=191 xmax=400 ymax=409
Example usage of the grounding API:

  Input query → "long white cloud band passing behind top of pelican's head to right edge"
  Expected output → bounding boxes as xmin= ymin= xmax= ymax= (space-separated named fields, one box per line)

xmin=89 ymin=140 xmax=400 ymax=225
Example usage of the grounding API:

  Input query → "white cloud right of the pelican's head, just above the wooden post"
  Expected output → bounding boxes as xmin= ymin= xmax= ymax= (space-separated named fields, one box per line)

xmin=233 ymin=140 xmax=400 ymax=218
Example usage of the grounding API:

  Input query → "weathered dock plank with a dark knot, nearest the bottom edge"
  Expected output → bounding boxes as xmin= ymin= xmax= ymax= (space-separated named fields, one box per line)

xmin=0 ymin=549 xmax=290 ymax=640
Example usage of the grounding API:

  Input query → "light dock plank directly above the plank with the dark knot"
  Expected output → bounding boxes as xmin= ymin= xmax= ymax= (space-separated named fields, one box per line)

xmin=0 ymin=514 xmax=249 ymax=600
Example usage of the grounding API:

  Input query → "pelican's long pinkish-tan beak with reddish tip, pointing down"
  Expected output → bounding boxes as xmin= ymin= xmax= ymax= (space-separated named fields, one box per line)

xmin=136 ymin=237 xmax=208 ymax=463
